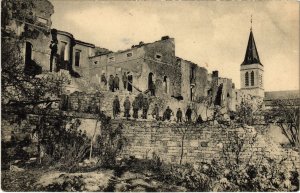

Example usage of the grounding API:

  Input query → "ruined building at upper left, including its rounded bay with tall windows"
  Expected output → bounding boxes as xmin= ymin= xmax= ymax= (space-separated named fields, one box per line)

xmin=1 ymin=0 xmax=108 ymax=77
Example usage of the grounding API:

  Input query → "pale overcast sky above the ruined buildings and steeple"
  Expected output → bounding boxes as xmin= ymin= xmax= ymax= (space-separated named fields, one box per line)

xmin=50 ymin=0 xmax=299 ymax=91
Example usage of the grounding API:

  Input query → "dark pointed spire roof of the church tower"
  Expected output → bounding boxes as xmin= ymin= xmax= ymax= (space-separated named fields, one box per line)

xmin=242 ymin=28 xmax=262 ymax=65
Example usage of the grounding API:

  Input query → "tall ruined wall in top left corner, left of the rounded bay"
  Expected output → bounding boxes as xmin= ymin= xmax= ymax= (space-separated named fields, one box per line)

xmin=3 ymin=0 xmax=54 ymax=72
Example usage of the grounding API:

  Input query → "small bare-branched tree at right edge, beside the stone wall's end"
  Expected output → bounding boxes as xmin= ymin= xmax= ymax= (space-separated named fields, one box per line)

xmin=265 ymin=97 xmax=300 ymax=148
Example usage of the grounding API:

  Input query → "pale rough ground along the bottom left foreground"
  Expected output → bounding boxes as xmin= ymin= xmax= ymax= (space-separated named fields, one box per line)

xmin=1 ymin=167 xmax=187 ymax=192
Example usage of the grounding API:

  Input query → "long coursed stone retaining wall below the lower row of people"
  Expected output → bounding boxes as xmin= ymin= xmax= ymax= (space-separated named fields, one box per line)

xmin=108 ymin=120 xmax=300 ymax=169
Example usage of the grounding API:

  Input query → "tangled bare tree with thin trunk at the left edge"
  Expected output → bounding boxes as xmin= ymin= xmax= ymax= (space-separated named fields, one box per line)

xmin=1 ymin=36 xmax=68 ymax=164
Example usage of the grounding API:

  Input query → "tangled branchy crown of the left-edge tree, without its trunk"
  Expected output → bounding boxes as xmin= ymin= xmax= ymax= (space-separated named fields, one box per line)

xmin=1 ymin=38 xmax=68 ymax=112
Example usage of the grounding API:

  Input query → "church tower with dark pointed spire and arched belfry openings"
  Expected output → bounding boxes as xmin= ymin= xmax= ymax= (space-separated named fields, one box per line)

xmin=240 ymin=18 xmax=264 ymax=98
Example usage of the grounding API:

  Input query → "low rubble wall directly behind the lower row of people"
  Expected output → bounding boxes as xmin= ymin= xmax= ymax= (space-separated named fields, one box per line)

xmin=62 ymin=91 xmax=213 ymax=122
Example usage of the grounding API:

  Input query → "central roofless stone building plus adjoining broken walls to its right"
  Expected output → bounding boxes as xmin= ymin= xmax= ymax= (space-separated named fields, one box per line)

xmin=90 ymin=36 xmax=212 ymax=101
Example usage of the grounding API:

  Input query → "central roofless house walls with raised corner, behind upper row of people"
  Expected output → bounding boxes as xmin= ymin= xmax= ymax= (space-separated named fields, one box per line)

xmin=90 ymin=38 xmax=182 ymax=96
